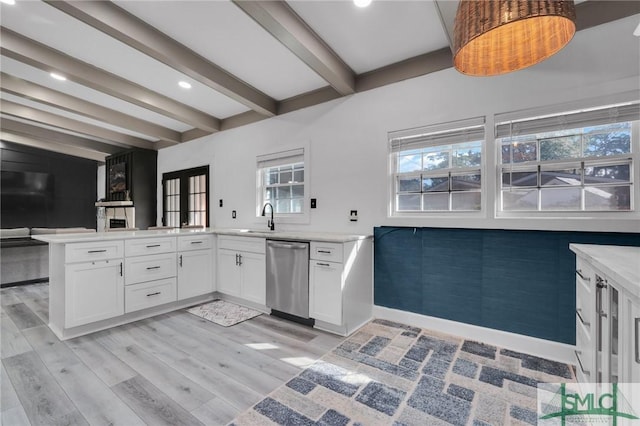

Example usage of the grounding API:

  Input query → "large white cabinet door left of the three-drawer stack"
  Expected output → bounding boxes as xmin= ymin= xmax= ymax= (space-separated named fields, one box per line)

xmin=65 ymin=260 xmax=124 ymax=328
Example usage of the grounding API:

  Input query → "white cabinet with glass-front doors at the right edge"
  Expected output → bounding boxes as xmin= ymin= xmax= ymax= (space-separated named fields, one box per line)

xmin=571 ymin=244 xmax=640 ymax=397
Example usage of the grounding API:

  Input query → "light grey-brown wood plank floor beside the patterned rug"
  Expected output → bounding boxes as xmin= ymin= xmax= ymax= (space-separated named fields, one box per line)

xmin=0 ymin=284 xmax=342 ymax=426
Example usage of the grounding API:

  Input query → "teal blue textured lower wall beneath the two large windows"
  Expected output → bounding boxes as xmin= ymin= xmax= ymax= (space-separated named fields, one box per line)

xmin=374 ymin=227 xmax=640 ymax=344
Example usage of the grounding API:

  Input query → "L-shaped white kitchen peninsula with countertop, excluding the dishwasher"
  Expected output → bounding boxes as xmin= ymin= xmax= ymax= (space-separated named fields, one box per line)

xmin=33 ymin=229 xmax=373 ymax=340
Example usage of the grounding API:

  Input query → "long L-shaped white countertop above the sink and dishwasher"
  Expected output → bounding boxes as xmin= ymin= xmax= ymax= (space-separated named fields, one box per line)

xmin=31 ymin=228 xmax=371 ymax=244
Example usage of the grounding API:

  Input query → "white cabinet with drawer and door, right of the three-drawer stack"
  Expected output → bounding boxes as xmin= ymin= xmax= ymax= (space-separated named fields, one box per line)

xmin=178 ymin=234 xmax=214 ymax=300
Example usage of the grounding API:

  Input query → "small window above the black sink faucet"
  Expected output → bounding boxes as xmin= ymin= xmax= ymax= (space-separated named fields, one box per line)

xmin=257 ymin=148 xmax=305 ymax=215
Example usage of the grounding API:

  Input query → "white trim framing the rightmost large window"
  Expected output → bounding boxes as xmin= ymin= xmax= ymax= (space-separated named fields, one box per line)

xmin=496 ymin=104 xmax=640 ymax=221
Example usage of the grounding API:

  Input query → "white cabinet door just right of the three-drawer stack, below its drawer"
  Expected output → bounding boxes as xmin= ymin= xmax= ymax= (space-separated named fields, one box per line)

xmin=178 ymin=250 xmax=213 ymax=300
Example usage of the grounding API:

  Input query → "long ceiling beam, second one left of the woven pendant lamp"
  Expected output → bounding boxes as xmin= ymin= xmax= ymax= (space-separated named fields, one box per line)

xmin=45 ymin=0 xmax=276 ymax=116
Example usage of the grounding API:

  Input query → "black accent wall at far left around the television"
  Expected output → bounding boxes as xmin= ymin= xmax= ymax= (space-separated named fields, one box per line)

xmin=0 ymin=141 xmax=98 ymax=228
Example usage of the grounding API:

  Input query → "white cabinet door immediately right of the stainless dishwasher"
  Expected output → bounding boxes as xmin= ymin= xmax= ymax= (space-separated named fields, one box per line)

xmin=309 ymin=260 xmax=342 ymax=325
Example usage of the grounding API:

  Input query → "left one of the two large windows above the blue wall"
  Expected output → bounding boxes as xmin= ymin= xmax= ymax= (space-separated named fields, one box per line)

xmin=389 ymin=117 xmax=484 ymax=214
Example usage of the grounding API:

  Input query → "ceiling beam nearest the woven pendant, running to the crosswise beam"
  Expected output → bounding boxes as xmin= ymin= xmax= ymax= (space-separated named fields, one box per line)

xmin=232 ymin=0 xmax=355 ymax=96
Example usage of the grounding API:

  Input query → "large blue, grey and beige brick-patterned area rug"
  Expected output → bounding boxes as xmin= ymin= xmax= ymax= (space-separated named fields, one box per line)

xmin=231 ymin=320 xmax=575 ymax=426
